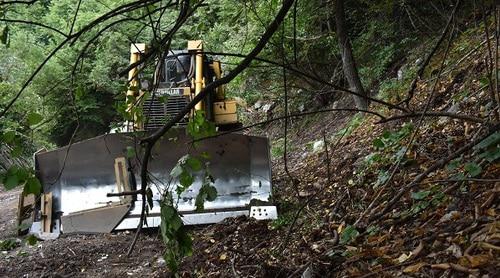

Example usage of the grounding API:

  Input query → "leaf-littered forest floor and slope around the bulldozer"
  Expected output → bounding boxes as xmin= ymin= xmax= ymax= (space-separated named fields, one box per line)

xmin=0 ymin=21 xmax=500 ymax=277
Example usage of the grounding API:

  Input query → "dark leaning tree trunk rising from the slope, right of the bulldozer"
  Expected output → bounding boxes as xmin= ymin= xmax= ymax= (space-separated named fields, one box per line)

xmin=335 ymin=0 xmax=368 ymax=110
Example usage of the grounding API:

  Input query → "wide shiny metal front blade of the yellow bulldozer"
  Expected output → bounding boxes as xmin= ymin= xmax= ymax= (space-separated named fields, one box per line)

xmin=35 ymin=128 xmax=276 ymax=233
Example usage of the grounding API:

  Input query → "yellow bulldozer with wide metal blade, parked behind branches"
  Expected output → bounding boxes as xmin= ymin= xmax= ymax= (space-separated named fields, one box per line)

xmin=19 ymin=41 xmax=277 ymax=239
